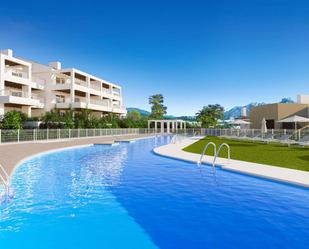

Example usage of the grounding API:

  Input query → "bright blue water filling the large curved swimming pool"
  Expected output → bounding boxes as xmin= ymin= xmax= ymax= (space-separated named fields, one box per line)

xmin=0 ymin=137 xmax=309 ymax=249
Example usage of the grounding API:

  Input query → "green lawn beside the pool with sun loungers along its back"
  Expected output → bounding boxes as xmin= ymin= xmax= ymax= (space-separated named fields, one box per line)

xmin=184 ymin=137 xmax=309 ymax=171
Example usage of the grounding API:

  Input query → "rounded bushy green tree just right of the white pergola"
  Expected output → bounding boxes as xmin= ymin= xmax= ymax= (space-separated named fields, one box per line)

xmin=196 ymin=104 xmax=224 ymax=128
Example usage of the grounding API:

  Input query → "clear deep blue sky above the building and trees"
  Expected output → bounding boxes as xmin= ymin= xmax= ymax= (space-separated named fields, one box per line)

xmin=0 ymin=0 xmax=309 ymax=116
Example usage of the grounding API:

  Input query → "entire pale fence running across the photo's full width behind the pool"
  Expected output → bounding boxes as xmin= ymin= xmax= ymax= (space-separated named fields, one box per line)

xmin=0 ymin=128 xmax=309 ymax=143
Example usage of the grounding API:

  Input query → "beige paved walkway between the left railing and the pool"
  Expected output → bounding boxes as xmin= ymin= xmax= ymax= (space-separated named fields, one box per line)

xmin=0 ymin=135 xmax=154 ymax=175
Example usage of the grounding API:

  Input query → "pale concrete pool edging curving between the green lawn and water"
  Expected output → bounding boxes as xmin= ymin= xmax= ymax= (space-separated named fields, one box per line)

xmin=153 ymin=138 xmax=309 ymax=188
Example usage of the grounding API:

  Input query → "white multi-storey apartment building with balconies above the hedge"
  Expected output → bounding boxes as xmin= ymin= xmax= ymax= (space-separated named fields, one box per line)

xmin=0 ymin=49 xmax=126 ymax=117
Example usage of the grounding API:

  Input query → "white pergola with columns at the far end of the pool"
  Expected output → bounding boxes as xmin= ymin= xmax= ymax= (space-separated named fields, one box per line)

xmin=148 ymin=119 xmax=186 ymax=133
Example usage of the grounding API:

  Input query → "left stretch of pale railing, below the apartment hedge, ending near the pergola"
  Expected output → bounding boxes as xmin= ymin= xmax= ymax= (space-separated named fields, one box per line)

xmin=0 ymin=128 xmax=155 ymax=143
